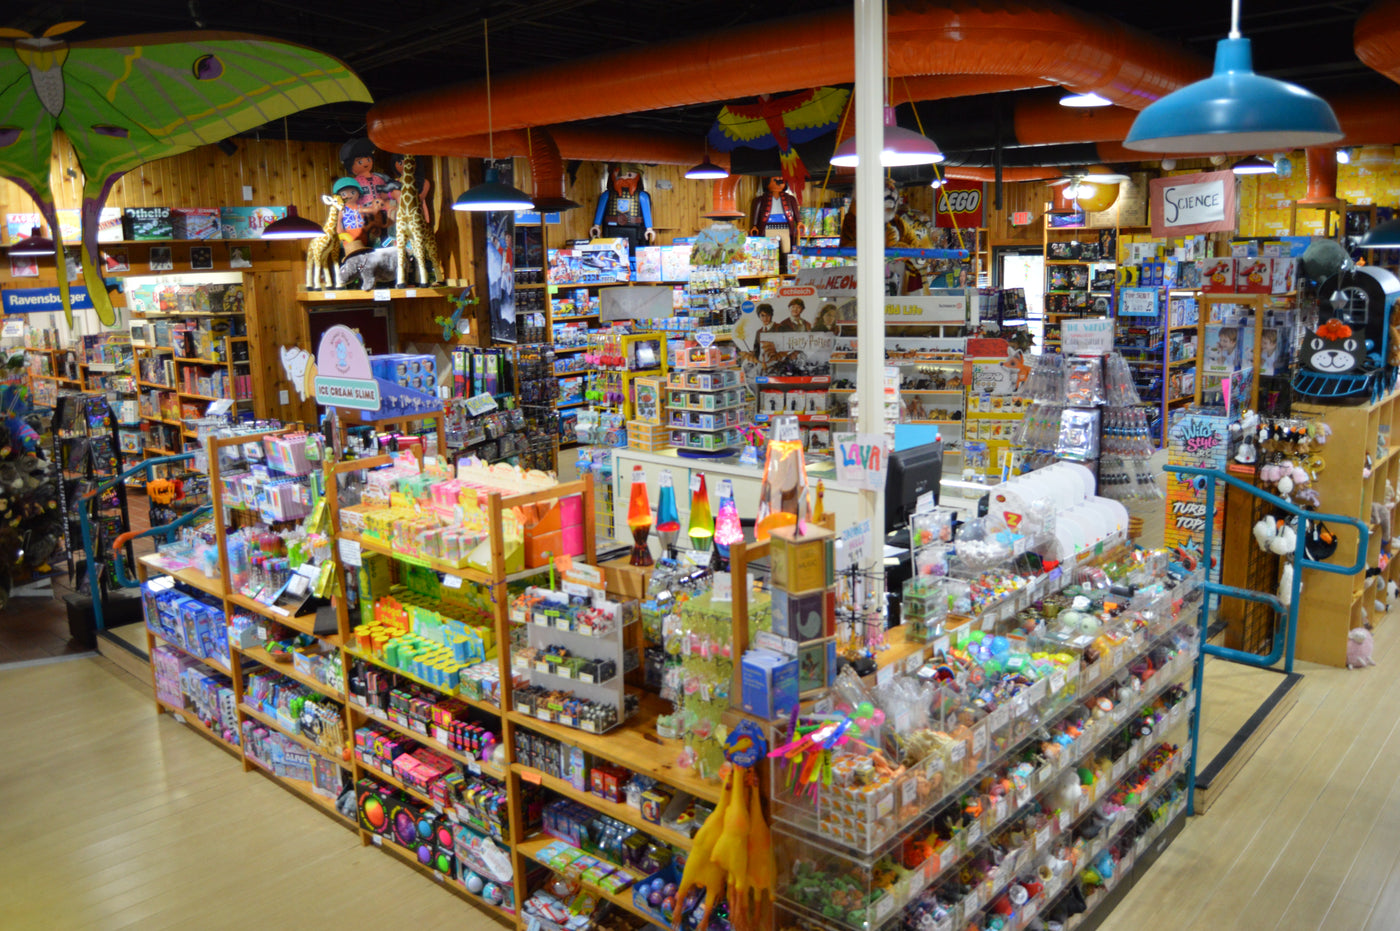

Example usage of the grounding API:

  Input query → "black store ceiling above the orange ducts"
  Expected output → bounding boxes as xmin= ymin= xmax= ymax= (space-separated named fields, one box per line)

xmin=0 ymin=0 xmax=1377 ymax=158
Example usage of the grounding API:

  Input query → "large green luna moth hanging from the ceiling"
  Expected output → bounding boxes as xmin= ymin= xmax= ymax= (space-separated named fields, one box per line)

xmin=0 ymin=22 xmax=370 ymax=325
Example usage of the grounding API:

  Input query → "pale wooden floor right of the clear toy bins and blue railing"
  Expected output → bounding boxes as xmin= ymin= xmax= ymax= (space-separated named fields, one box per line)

xmin=1102 ymin=602 xmax=1400 ymax=931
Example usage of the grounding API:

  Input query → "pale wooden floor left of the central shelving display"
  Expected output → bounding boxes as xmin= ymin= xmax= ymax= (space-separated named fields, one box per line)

xmin=0 ymin=658 xmax=501 ymax=931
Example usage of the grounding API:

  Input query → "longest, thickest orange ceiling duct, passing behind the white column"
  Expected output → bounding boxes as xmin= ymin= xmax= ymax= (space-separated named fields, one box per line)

xmin=368 ymin=0 xmax=1208 ymax=154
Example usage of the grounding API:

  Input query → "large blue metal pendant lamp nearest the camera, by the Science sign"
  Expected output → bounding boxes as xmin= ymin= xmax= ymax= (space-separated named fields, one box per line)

xmin=1123 ymin=0 xmax=1343 ymax=154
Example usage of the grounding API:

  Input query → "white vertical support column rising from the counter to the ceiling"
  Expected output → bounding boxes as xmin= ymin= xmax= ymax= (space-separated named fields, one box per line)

xmin=854 ymin=0 xmax=885 ymax=534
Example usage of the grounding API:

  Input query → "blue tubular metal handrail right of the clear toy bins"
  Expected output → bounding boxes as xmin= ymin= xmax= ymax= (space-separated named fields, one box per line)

xmin=1166 ymin=465 xmax=1371 ymax=815
